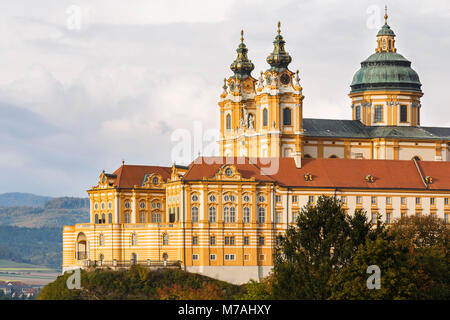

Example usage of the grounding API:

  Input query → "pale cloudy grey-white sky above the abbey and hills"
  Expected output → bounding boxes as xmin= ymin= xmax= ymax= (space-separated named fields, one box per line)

xmin=0 ymin=0 xmax=450 ymax=196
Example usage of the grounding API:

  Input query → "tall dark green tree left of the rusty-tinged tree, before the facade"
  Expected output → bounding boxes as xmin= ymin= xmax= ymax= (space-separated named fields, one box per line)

xmin=273 ymin=196 xmax=384 ymax=299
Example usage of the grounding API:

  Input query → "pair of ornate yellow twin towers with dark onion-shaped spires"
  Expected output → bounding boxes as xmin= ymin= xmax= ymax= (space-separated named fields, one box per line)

xmin=219 ymin=23 xmax=303 ymax=157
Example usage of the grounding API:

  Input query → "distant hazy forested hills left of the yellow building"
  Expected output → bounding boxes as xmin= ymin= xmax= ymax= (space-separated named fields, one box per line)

xmin=0 ymin=194 xmax=89 ymax=268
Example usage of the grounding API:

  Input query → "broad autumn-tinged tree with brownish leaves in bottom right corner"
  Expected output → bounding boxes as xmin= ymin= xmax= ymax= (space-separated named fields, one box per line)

xmin=330 ymin=216 xmax=450 ymax=300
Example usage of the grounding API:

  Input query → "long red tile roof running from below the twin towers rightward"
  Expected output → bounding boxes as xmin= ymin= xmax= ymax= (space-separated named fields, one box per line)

xmin=184 ymin=157 xmax=450 ymax=190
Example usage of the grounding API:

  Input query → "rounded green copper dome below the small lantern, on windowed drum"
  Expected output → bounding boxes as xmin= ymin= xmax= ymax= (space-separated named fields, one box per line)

xmin=350 ymin=52 xmax=422 ymax=93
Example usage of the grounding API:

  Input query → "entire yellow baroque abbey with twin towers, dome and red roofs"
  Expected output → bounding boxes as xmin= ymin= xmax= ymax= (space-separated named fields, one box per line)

xmin=63 ymin=15 xmax=450 ymax=283
